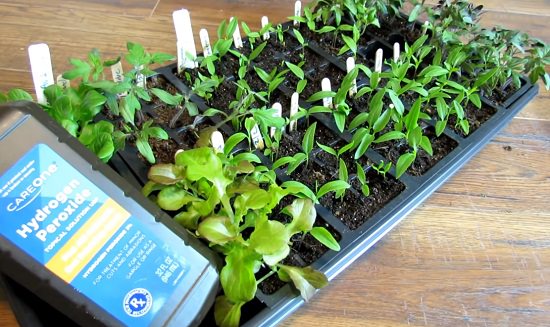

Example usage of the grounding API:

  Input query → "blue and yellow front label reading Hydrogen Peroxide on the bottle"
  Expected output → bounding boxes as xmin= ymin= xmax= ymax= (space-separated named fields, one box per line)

xmin=0 ymin=144 xmax=189 ymax=326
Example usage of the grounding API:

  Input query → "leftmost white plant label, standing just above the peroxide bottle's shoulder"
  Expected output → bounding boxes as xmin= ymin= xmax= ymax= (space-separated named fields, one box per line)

xmin=28 ymin=43 xmax=54 ymax=104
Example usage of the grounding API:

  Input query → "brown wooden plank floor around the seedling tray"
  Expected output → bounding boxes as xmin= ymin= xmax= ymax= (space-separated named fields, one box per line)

xmin=0 ymin=0 xmax=550 ymax=327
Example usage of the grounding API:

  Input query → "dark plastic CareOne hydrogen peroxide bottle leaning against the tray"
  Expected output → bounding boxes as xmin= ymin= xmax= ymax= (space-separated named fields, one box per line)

xmin=0 ymin=102 xmax=218 ymax=327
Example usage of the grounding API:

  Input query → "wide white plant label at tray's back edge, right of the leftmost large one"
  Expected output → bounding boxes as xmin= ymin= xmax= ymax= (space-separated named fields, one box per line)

xmin=172 ymin=9 xmax=197 ymax=72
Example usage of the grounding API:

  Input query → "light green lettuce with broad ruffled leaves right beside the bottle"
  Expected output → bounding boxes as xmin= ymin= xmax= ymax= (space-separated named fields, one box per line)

xmin=143 ymin=147 xmax=337 ymax=326
